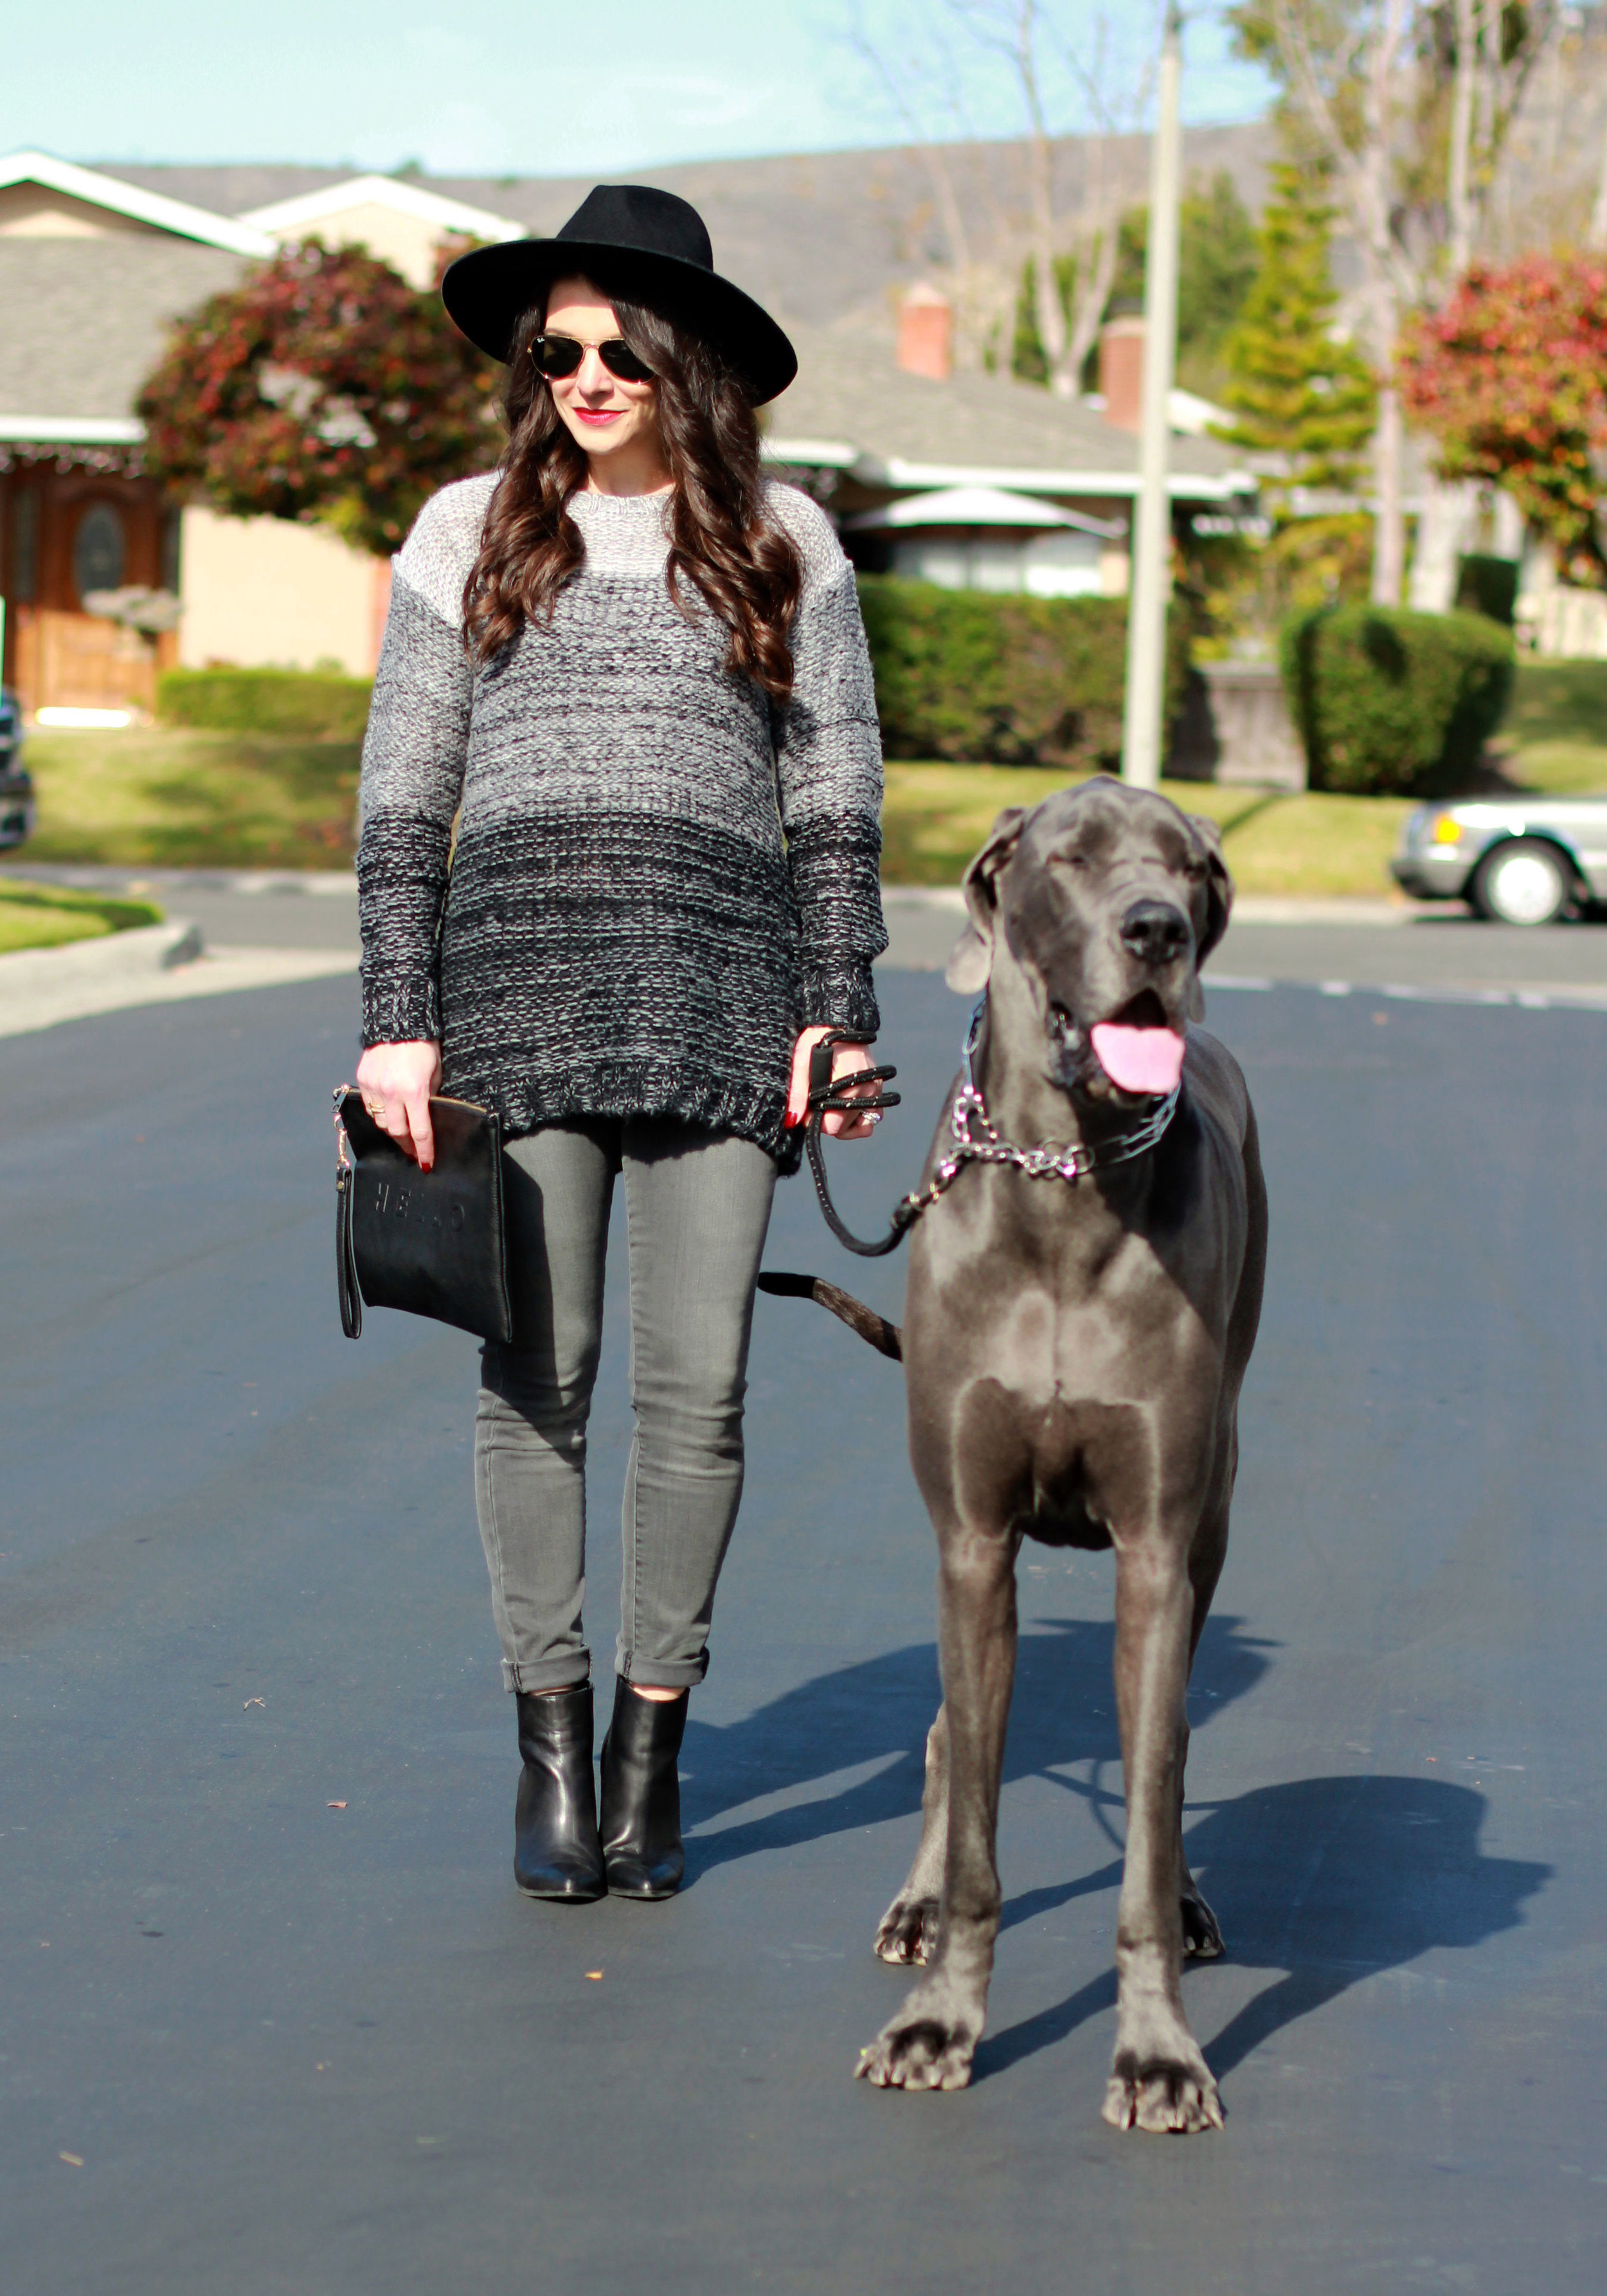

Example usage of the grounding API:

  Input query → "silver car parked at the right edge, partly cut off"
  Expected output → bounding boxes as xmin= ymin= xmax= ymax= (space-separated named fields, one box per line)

xmin=1389 ymin=794 xmax=1607 ymax=926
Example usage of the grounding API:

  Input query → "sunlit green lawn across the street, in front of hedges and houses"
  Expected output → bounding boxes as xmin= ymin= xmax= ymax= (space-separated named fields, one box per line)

xmin=15 ymin=661 xmax=1607 ymax=898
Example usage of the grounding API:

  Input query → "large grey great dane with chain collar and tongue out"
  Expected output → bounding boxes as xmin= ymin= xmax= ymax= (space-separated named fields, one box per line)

xmin=826 ymin=780 xmax=1267 ymax=2131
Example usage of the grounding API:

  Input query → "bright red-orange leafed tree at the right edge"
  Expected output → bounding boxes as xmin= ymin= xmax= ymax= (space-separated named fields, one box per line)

xmin=1401 ymin=255 xmax=1607 ymax=590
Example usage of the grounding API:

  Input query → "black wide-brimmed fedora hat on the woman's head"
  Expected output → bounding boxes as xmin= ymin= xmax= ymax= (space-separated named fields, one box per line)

xmin=441 ymin=184 xmax=799 ymax=406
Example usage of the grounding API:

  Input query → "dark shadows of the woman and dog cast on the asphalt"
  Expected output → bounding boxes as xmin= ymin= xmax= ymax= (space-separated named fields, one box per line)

xmin=707 ymin=1617 xmax=1552 ymax=2080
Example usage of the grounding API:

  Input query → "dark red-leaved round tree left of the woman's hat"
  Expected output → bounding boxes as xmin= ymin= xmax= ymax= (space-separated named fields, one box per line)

xmin=136 ymin=238 xmax=503 ymax=553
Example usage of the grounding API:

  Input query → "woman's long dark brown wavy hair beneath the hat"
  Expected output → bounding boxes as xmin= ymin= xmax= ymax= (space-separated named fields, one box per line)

xmin=463 ymin=278 xmax=804 ymax=703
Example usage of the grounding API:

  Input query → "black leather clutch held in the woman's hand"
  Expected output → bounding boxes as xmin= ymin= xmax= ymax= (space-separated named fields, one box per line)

xmin=335 ymin=1084 xmax=514 ymax=1341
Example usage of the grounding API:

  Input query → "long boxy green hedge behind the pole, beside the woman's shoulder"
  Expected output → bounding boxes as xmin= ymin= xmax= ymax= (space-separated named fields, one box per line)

xmin=859 ymin=574 xmax=1189 ymax=771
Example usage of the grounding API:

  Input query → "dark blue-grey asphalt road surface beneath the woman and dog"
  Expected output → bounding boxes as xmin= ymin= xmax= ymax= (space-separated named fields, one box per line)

xmin=0 ymin=974 xmax=1607 ymax=2296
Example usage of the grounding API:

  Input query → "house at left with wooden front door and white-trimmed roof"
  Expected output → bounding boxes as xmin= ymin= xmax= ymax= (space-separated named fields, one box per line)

xmin=0 ymin=152 xmax=521 ymax=712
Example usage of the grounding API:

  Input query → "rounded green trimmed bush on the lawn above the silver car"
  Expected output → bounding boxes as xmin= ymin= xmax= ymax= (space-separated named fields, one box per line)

xmin=1279 ymin=606 xmax=1515 ymax=796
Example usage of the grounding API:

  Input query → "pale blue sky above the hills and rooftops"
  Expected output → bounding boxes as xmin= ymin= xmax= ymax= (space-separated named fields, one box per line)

xmin=0 ymin=0 xmax=1265 ymax=174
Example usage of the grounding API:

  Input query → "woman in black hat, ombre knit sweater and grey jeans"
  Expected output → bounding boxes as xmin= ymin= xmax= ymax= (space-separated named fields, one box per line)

xmin=358 ymin=186 xmax=886 ymax=1901
